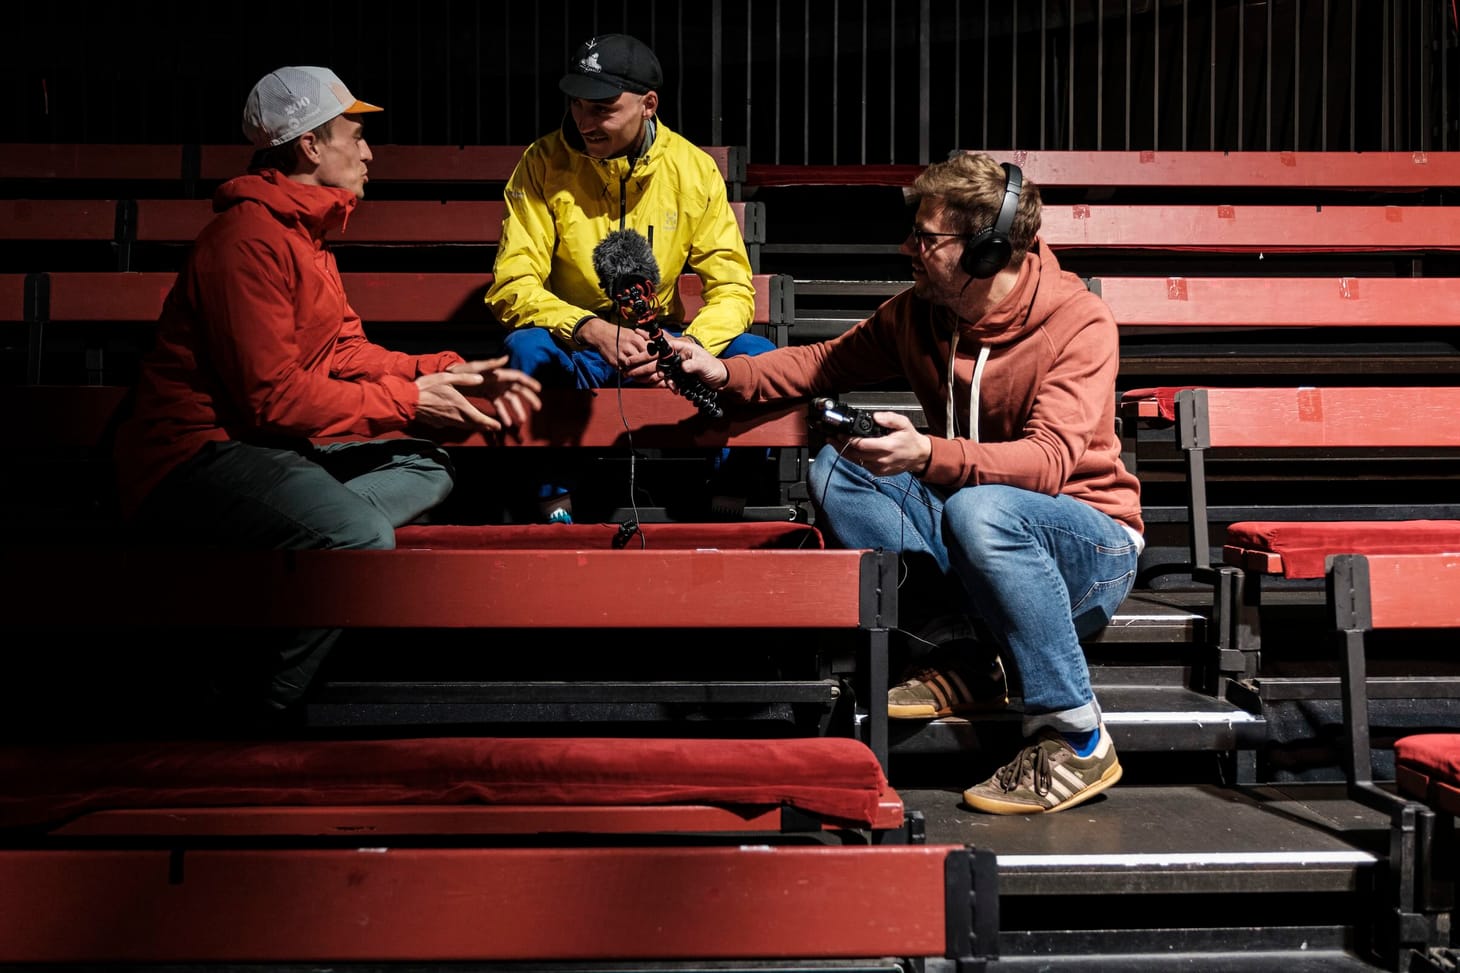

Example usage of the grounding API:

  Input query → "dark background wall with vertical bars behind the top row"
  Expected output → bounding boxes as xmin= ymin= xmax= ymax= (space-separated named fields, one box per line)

xmin=11 ymin=0 xmax=1460 ymax=157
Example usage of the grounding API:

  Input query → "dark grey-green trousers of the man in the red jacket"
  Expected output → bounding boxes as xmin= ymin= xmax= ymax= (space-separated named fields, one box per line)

xmin=133 ymin=438 xmax=456 ymax=711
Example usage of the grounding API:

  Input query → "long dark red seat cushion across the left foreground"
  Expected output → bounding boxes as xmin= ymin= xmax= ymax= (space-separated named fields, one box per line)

xmin=0 ymin=736 xmax=889 ymax=825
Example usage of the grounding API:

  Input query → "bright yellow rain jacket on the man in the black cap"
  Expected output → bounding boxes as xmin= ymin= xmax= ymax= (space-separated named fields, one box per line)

xmin=486 ymin=120 xmax=755 ymax=355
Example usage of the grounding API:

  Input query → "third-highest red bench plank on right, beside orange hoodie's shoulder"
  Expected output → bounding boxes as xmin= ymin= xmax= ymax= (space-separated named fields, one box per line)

xmin=1092 ymin=276 xmax=1460 ymax=329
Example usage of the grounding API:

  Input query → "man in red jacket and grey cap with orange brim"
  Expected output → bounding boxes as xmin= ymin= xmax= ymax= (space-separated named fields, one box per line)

xmin=115 ymin=67 xmax=542 ymax=716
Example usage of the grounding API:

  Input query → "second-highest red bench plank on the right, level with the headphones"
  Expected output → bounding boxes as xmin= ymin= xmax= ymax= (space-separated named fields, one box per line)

xmin=1040 ymin=203 xmax=1460 ymax=253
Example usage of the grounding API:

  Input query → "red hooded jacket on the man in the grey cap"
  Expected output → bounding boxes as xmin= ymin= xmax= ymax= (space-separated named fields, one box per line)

xmin=115 ymin=169 xmax=461 ymax=514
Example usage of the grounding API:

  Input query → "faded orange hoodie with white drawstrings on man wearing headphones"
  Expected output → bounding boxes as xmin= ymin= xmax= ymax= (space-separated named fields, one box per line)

xmin=726 ymin=241 xmax=1143 ymax=532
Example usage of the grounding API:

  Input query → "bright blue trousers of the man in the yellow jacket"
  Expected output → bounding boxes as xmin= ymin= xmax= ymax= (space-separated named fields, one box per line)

xmin=504 ymin=327 xmax=775 ymax=511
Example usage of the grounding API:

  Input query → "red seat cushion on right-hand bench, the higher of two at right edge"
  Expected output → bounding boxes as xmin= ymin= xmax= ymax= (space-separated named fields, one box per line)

xmin=1226 ymin=520 xmax=1460 ymax=577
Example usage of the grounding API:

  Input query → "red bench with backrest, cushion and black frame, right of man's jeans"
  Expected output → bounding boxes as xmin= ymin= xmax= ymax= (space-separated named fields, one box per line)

xmin=1109 ymin=387 xmax=1460 ymax=773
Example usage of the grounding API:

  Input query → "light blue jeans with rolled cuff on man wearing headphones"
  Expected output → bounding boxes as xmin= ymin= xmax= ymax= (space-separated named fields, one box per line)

xmin=809 ymin=444 xmax=1140 ymax=735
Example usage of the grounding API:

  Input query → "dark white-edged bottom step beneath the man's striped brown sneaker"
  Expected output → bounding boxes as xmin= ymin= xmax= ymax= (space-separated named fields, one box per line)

xmin=899 ymin=770 xmax=1388 ymax=894
